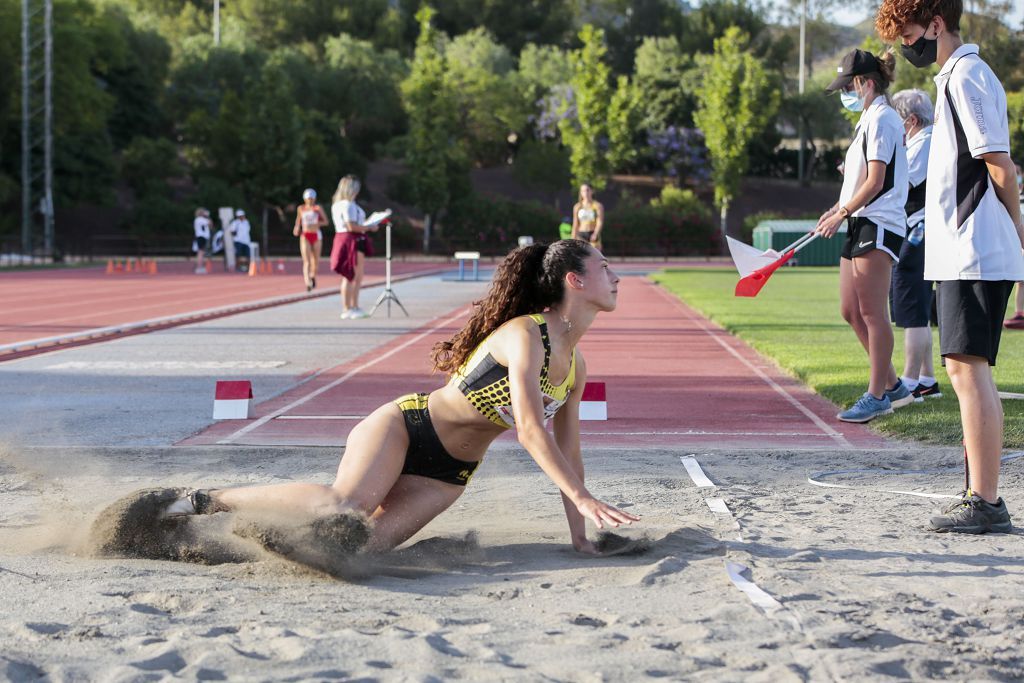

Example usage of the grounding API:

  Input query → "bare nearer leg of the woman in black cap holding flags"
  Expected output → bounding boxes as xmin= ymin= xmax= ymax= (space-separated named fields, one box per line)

xmin=852 ymin=249 xmax=897 ymax=397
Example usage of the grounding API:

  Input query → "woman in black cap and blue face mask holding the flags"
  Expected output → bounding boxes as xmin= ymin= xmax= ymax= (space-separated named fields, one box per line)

xmin=815 ymin=50 xmax=913 ymax=422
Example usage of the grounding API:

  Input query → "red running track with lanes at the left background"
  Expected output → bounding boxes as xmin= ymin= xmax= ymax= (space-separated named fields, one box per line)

xmin=0 ymin=260 xmax=452 ymax=360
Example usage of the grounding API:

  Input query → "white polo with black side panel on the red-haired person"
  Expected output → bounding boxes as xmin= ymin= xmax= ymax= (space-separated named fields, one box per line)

xmin=925 ymin=45 xmax=1024 ymax=281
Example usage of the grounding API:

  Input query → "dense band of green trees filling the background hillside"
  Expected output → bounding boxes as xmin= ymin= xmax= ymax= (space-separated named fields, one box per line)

xmin=0 ymin=0 xmax=1024 ymax=253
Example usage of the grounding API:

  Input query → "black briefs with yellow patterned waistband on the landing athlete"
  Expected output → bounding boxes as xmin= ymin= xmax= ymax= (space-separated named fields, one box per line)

xmin=394 ymin=393 xmax=480 ymax=486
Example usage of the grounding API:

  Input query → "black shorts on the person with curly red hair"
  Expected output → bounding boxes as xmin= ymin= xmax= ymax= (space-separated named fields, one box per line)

xmin=935 ymin=280 xmax=1014 ymax=366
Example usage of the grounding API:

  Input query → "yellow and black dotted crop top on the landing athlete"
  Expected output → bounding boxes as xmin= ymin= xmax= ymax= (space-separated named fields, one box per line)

xmin=451 ymin=313 xmax=575 ymax=429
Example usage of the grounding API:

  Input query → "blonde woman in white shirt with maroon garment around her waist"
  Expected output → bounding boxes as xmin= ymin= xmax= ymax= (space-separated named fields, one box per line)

xmin=331 ymin=175 xmax=377 ymax=321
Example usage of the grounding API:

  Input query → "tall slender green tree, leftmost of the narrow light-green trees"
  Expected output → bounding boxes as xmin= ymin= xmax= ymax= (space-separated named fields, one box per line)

xmin=401 ymin=5 xmax=455 ymax=252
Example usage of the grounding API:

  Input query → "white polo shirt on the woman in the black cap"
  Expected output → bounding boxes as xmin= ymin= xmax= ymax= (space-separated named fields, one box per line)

xmin=839 ymin=96 xmax=908 ymax=240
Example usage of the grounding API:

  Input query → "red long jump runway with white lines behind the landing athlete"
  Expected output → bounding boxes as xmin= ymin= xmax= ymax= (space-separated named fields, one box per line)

xmin=178 ymin=276 xmax=890 ymax=450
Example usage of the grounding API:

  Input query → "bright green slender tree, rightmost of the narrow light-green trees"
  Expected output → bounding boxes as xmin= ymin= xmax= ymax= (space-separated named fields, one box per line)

xmin=694 ymin=27 xmax=778 ymax=237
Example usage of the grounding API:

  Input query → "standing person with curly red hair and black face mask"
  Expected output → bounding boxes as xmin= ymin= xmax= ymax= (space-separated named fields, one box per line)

xmin=874 ymin=0 xmax=1024 ymax=533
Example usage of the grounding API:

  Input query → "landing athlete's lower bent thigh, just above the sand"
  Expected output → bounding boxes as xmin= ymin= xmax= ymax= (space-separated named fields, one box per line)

xmin=368 ymin=474 xmax=466 ymax=552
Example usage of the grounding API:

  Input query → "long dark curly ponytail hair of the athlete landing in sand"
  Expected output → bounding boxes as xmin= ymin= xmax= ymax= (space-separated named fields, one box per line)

xmin=432 ymin=240 xmax=591 ymax=374
